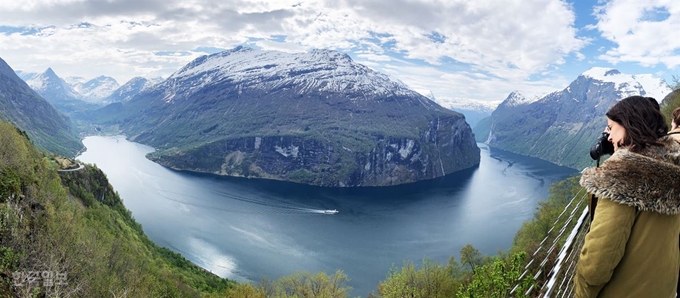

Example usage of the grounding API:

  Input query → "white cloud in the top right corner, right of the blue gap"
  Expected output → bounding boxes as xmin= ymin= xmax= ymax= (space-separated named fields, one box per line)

xmin=595 ymin=0 xmax=680 ymax=69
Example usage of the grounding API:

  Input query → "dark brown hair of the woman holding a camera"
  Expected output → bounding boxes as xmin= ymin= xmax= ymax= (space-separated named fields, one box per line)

xmin=607 ymin=96 xmax=668 ymax=152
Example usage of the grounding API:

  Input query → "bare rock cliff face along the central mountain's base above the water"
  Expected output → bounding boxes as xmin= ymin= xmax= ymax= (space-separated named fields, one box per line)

xmin=152 ymin=118 xmax=479 ymax=187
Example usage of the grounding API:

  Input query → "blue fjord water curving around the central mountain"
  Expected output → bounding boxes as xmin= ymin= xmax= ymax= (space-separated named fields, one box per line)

xmin=78 ymin=136 xmax=576 ymax=296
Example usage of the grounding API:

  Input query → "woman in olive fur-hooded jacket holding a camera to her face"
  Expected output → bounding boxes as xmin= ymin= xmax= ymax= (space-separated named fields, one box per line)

xmin=574 ymin=96 xmax=680 ymax=297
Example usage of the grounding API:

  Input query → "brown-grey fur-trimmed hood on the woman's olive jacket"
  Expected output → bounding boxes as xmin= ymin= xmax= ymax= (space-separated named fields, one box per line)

xmin=580 ymin=136 xmax=680 ymax=215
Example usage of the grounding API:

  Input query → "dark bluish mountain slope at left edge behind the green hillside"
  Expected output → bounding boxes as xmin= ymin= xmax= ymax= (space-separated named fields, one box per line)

xmin=0 ymin=59 xmax=83 ymax=157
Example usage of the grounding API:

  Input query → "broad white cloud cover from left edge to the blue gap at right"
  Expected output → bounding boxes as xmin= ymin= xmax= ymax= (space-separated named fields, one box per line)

xmin=0 ymin=0 xmax=584 ymax=99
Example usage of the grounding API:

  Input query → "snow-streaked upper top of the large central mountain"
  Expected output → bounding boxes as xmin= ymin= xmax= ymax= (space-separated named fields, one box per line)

xmin=159 ymin=47 xmax=425 ymax=102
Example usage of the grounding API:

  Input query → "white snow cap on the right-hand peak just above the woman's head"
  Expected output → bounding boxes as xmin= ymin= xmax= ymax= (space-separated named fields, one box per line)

xmin=581 ymin=67 xmax=673 ymax=101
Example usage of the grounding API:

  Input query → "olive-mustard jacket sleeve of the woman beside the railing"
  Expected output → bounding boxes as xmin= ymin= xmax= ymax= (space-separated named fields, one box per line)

xmin=574 ymin=198 xmax=636 ymax=298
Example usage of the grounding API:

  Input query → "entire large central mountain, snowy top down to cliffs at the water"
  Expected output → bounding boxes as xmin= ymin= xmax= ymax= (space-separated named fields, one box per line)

xmin=91 ymin=47 xmax=479 ymax=186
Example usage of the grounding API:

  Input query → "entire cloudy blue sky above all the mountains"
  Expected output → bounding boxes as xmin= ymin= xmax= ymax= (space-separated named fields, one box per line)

xmin=0 ymin=0 xmax=680 ymax=101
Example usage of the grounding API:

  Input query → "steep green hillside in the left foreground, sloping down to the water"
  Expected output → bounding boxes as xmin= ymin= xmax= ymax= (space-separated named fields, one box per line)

xmin=0 ymin=122 xmax=234 ymax=297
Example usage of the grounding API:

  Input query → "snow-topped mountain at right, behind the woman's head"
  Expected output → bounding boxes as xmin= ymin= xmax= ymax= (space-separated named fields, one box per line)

xmin=474 ymin=67 xmax=672 ymax=169
